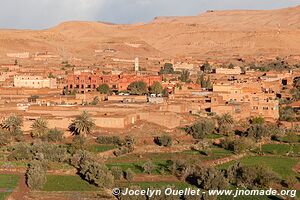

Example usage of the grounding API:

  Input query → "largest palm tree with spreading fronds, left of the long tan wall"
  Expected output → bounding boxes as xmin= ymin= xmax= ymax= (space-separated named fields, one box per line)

xmin=69 ymin=111 xmax=95 ymax=137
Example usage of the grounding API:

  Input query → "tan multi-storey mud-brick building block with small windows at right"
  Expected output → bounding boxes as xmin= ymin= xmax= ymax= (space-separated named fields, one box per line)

xmin=211 ymin=85 xmax=279 ymax=121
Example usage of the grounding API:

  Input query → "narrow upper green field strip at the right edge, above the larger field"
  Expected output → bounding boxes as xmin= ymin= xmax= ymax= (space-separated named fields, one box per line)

xmin=262 ymin=144 xmax=300 ymax=155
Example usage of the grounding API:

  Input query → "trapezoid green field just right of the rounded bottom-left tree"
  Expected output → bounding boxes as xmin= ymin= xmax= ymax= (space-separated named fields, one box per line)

xmin=42 ymin=175 xmax=99 ymax=191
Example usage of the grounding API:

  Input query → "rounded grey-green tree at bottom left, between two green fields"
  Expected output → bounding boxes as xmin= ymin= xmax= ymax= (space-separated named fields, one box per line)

xmin=25 ymin=161 xmax=47 ymax=190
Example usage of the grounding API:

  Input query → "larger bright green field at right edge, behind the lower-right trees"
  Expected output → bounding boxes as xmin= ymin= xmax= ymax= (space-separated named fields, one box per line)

xmin=219 ymin=156 xmax=298 ymax=178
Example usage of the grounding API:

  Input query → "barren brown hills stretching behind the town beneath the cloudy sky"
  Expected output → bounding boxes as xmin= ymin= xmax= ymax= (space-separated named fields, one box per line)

xmin=0 ymin=6 xmax=300 ymax=63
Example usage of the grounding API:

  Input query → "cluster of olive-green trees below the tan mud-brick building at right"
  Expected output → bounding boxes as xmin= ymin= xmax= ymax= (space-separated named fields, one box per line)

xmin=185 ymin=114 xmax=298 ymax=155
